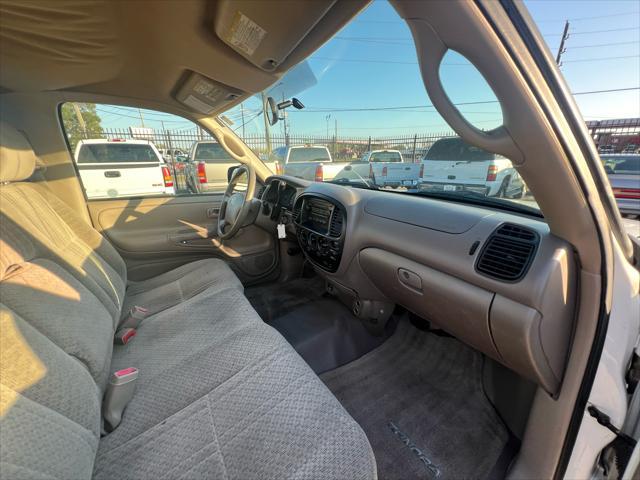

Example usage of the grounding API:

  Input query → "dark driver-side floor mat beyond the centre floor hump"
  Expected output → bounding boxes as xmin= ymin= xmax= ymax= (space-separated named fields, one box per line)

xmin=244 ymin=276 xmax=325 ymax=323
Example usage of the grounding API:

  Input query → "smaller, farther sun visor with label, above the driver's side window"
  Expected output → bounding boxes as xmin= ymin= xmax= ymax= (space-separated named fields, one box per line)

xmin=176 ymin=72 xmax=244 ymax=115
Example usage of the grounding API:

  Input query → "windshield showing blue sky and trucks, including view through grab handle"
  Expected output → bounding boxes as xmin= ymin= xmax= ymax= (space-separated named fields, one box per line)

xmin=220 ymin=0 xmax=564 ymax=213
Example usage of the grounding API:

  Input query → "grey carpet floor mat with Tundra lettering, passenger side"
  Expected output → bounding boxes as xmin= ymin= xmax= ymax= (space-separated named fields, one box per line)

xmin=320 ymin=319 xmax=508 ymax=480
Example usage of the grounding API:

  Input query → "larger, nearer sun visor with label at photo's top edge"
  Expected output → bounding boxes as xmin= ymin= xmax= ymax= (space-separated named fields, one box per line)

xmin=214 ymin=0 xmax=336 ymax=71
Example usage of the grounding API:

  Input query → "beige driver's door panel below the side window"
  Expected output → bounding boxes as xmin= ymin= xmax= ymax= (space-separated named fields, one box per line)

xmin=88 ymin=194 xmax=277 ymax=282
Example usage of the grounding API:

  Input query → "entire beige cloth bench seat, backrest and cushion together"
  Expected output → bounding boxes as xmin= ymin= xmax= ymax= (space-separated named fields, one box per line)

xmin=0 ymin=124 xmax=376 ymax=480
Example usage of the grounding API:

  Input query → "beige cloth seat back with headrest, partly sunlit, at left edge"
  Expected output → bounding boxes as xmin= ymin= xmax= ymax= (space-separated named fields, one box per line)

xmin=0 ymin=123 xmax=126 ymax=478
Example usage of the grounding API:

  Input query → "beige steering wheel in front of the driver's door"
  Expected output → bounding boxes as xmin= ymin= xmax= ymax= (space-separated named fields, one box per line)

xmin=217 ymin=165 xmax=256 ymax=240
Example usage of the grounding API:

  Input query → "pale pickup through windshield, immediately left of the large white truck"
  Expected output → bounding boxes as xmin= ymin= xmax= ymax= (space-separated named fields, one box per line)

xmin=354 ymin=150 xmax=422 ymax=188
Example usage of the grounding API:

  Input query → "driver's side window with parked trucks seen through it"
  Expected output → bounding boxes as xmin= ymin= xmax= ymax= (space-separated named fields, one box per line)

xmin=61 ymin=103 xmax=238 ymax=199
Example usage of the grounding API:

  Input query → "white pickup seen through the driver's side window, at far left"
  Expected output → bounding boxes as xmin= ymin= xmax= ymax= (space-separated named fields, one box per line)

xmin=75 ymin=139 xmax=175 ymax=199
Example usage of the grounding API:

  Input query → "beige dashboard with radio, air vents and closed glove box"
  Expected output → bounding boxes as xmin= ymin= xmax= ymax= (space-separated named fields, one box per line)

xmin=262 ymin=176 xmax=577 ymax=395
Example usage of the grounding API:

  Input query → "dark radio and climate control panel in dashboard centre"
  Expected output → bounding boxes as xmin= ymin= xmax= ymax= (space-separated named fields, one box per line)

xmin=293 ymin=193 xmax=346 ymax=273
